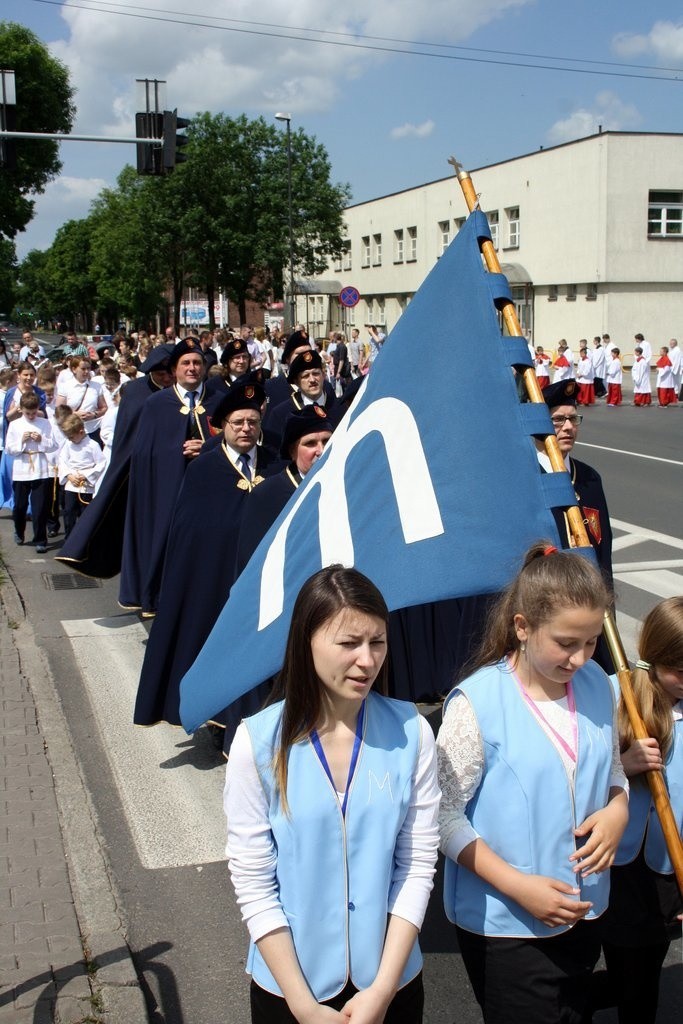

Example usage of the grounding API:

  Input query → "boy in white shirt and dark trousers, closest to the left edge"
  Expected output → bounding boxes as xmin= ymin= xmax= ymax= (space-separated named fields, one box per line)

xmin=5 ymin=391 xmax=56 ymax=555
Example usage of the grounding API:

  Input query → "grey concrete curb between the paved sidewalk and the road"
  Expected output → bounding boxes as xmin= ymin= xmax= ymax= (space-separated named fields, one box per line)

xmin=0 ymin=565 xmax=150 ymax=1024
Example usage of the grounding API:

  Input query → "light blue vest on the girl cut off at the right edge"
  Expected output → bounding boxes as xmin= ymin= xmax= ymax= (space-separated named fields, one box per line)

xmin=614 ymin=708 xmax=683 ymax=874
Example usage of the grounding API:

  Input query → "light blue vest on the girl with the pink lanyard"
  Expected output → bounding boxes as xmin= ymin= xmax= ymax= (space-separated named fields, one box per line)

xmin=443 ymin=662 xmax=614 ymax=938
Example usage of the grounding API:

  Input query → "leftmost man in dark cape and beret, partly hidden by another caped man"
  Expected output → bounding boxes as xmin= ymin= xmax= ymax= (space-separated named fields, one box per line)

xmin=56 ymin=345 xmax=174 ymax=580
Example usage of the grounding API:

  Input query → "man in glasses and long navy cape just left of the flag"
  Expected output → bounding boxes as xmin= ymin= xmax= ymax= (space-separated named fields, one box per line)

xmin=134 ymin=384 xmax=279 ymax=725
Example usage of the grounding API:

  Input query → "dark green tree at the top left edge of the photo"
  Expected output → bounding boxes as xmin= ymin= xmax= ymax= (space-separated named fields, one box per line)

xmin=0 ymin=22 xmax=76 ymax=239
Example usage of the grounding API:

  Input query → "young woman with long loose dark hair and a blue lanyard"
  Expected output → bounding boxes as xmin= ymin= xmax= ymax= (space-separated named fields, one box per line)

xmin=224 ymin=565 xmax=439 ymax=1024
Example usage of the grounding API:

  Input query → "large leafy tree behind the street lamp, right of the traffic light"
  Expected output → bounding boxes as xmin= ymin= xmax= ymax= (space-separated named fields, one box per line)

xmin=183 ymin=114 xmax=349 ymax=319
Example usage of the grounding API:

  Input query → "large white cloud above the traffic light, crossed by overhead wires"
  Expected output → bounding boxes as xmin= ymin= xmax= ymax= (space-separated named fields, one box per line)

xmin=44 ymin=0 xmax=533 ymax=134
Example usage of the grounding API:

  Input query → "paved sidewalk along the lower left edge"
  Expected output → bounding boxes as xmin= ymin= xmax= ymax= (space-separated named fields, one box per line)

xmin=0 ymin=574 xmax=147 ymax=1024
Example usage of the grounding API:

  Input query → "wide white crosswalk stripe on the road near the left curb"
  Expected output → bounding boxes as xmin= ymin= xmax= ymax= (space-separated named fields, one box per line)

xmin=61 ymin=614 xmax=225 ymax=868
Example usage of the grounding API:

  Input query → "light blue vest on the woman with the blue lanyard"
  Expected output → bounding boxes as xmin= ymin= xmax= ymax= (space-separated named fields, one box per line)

xmin=246 ymin=692 xmax=422 ymax=1001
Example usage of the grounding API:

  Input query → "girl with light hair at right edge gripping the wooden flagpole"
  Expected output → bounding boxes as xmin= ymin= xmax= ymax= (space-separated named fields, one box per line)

xmin=596 ymin=597 xmax=683 ymax=1024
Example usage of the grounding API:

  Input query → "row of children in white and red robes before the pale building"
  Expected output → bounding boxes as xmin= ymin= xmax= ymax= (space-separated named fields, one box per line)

xmin=529 ymin=334 xmax=683 ymax=409
